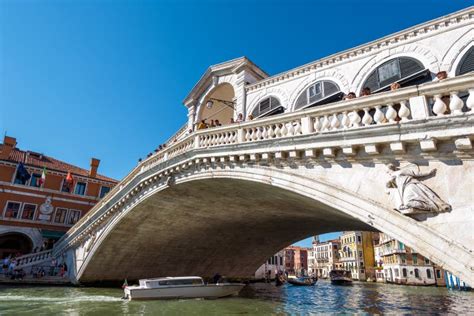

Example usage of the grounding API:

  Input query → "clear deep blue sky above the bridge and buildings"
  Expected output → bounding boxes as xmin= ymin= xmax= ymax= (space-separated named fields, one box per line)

xmin=0 ymin=0 xmax=469 ymax=245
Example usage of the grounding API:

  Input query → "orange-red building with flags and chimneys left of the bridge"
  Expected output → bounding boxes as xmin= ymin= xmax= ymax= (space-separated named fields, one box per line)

xmin=0 ymin=136 xmax=117 ymax=258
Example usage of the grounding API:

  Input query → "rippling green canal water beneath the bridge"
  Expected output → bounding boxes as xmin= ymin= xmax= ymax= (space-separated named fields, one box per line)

xmin=0 ymin=280 xmax=474 ymax=316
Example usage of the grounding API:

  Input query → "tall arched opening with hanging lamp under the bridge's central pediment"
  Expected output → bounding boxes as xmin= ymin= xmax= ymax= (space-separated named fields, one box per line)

xmin=195 ymin=83 xmax=235 ymax=127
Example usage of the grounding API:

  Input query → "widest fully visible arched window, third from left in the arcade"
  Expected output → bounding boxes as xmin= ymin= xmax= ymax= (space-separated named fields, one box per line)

xmin=362 ymin=57 xmax=431 ymax=93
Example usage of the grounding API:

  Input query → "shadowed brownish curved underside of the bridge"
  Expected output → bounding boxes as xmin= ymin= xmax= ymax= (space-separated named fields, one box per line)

xmin=79 ymin=179 xmax=373 ymax=283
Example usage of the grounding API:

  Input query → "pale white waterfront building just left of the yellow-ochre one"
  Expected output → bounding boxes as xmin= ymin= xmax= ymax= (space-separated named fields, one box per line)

xmin=313 ymin=239 xmax=341 ymax=278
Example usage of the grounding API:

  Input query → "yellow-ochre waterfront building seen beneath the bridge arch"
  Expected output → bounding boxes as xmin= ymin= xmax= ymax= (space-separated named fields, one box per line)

xmin=339 ymin=231 xmax=375 ymax=281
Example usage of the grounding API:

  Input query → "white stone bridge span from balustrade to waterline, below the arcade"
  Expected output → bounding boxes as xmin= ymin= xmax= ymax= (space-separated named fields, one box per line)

xmin=53 ymin=74 xmax=474 ymax=284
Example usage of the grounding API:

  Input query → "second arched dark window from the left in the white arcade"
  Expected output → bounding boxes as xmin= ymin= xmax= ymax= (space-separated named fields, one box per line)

xmin=295 ymin=80 xmax=344 ymax=110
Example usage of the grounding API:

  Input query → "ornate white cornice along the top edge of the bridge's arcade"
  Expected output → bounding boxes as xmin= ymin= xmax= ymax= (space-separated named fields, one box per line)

xmin=246 ymin=6 xmax=474 ymax=92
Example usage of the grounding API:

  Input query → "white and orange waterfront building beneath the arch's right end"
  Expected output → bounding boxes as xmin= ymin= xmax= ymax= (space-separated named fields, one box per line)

xmin=375 ymin=233 xmax=438 ymax=285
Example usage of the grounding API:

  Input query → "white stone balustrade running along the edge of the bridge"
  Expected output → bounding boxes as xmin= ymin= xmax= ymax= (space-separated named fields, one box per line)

xmin=55 ymin=74 xmax=474 ymax=254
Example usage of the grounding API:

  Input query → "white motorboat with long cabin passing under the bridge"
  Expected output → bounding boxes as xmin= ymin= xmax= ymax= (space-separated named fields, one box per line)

xmin=124 ymin=276 xmax=245 ymax=300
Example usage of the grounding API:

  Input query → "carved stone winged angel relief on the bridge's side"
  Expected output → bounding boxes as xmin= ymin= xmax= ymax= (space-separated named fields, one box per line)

xmin=386 ymin=164 xmax=451 ymax=216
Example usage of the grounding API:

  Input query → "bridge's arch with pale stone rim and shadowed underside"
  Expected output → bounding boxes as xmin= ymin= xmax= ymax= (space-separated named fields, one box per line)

xmin=73 ymin=165 xmax=466 ymax=282
